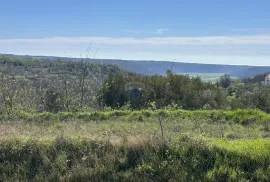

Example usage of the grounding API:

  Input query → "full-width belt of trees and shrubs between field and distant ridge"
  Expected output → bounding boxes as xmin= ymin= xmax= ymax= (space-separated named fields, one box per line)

xmin=0 ymin=57 xmax=270 ymax=113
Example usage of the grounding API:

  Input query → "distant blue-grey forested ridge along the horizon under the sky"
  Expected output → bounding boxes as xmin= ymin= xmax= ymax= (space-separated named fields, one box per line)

xmin=1 ymin=55 xmax=270 ymax=78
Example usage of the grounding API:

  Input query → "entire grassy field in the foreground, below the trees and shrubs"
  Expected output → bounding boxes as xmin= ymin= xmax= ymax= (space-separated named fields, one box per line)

xmin=0 ymin=110 xmax=270 ymax=181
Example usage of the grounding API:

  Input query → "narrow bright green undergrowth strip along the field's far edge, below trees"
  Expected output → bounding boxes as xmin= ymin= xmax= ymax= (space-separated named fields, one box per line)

xmin=0 ymin=109 xmax=270 ymax=125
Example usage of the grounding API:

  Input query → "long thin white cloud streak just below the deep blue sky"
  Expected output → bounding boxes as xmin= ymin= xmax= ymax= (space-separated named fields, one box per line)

xmin=0 ymin=34 xmax=270 ymax=46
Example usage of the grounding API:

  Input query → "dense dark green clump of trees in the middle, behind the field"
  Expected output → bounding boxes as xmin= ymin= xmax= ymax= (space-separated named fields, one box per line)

xmin=98 ymin=74 xmax=226 ymax=109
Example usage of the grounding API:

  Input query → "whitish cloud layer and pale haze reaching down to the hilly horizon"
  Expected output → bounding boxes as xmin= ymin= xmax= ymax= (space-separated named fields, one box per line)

xmin=0 ymin=34 xmax=270 ymax=65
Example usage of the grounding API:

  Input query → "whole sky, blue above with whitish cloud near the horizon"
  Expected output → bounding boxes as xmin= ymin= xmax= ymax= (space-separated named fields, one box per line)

xmin=0 ymin=0 xmax=270 ymax=65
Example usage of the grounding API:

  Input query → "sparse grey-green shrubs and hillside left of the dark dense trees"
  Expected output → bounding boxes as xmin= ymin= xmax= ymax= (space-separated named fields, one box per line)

xmin=0 ymin=56 xmax=126 ymax=113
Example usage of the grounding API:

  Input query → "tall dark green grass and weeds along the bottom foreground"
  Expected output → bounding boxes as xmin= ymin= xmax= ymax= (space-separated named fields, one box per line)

xmin=0 ymin=137 xmax=270 ymax=181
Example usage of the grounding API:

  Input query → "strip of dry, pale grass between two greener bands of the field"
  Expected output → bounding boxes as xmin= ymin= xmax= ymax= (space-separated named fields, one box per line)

xmin=0 ymin=114 xmax=270 ymax=145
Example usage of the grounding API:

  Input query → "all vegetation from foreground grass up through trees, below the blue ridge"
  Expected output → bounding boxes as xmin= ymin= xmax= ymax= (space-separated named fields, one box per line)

xmin=0 ymin=57 xmax=270 ymax=181
